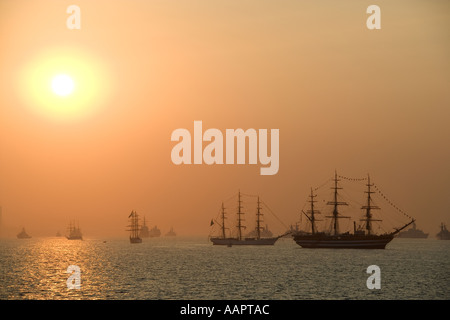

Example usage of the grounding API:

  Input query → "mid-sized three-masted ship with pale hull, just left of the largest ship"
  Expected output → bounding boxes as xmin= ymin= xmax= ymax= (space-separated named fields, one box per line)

xmin=210 ymin=191 xmax=281 ymax=246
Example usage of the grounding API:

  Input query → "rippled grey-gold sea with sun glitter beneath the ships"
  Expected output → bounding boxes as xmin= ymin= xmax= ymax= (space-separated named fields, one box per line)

xmin=0 ymin=237 xmax=450 ymax=300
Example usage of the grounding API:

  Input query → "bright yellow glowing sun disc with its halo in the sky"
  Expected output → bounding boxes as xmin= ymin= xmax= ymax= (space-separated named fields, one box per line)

xmin=16 ymin=47 xmax=111 ymax=121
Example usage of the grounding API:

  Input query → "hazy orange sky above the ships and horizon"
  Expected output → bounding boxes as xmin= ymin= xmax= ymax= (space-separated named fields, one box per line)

xmin=0 ymin=0 xmax=450 ymax=238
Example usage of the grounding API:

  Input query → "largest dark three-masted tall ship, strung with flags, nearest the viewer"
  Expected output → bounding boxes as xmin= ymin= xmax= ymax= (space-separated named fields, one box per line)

xmin=293 ymin=172 xmax=415 ymax=249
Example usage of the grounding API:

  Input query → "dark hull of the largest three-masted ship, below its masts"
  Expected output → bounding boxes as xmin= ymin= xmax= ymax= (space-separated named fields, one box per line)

xmin=293 ymin=235 xmax=393 ymax=249
